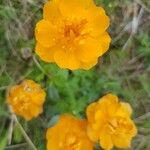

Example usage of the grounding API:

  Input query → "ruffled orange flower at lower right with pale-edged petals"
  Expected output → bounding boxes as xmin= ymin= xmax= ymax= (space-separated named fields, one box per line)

xmin=86 ymin=94 xmax=137 ymax=150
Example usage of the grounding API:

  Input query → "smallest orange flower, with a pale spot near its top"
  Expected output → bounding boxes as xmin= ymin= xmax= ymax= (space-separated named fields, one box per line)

xmin=7 ymin=80 xmax=46 ymax=120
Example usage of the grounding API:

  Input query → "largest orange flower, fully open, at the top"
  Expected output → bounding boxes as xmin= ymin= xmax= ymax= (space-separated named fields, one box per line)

xmin=35 ymin=0 xmax=111 ymax=70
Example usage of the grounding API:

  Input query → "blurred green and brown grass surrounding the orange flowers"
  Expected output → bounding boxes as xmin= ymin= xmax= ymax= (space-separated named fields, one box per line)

xmin=0 ymin=0 xmax=150 ymax=150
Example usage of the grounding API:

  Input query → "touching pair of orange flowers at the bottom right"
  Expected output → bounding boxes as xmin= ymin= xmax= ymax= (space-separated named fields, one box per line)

xmin=47 ymin=94 xmax=137 ymax=150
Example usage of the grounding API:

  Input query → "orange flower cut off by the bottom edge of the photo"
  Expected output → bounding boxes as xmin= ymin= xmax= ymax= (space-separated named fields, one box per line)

xmin=46 ymin=115 xmax=94 ymax=150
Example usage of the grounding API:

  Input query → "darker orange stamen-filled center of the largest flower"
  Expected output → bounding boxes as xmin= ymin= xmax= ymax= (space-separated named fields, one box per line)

xmin=55 ymin=19 xmax=88 ymax=52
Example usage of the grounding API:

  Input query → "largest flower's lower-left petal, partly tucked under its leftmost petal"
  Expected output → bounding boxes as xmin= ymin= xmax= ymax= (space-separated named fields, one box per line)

xmin=35 ymin=43 xmax=56 ymax=62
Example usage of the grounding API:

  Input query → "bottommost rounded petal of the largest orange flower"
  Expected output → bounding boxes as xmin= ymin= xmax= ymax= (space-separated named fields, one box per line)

xmin=54 ymin=50 xmax=80 ymax=70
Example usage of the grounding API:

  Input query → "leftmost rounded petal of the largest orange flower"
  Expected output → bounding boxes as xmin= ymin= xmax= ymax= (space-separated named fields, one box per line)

xmin=35 ymin=20 xmax=56 ymax=47
